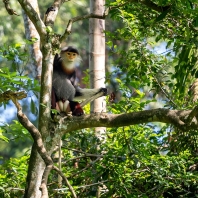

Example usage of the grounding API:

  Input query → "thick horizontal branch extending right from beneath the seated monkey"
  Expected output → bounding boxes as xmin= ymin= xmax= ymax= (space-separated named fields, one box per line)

xmin=58 ymin=108 xmax=198 ymax=133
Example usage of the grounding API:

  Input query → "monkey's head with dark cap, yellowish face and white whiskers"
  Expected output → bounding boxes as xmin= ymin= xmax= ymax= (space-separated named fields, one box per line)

xmin=60 ymin=46 xmax=81 ymax=70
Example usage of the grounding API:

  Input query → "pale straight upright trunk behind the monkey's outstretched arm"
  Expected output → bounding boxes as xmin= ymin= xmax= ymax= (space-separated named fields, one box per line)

xmin=89 ymin=0 xmax=106 ymax=197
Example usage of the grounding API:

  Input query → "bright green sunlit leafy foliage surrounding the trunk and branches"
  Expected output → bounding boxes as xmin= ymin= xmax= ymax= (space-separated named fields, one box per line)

xmin=0 ymin=0 xmax=198 ymax=198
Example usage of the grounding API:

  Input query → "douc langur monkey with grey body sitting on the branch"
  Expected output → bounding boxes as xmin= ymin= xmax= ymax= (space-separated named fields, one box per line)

xmin=51 ymin=46 xmax=107 ymax=116
